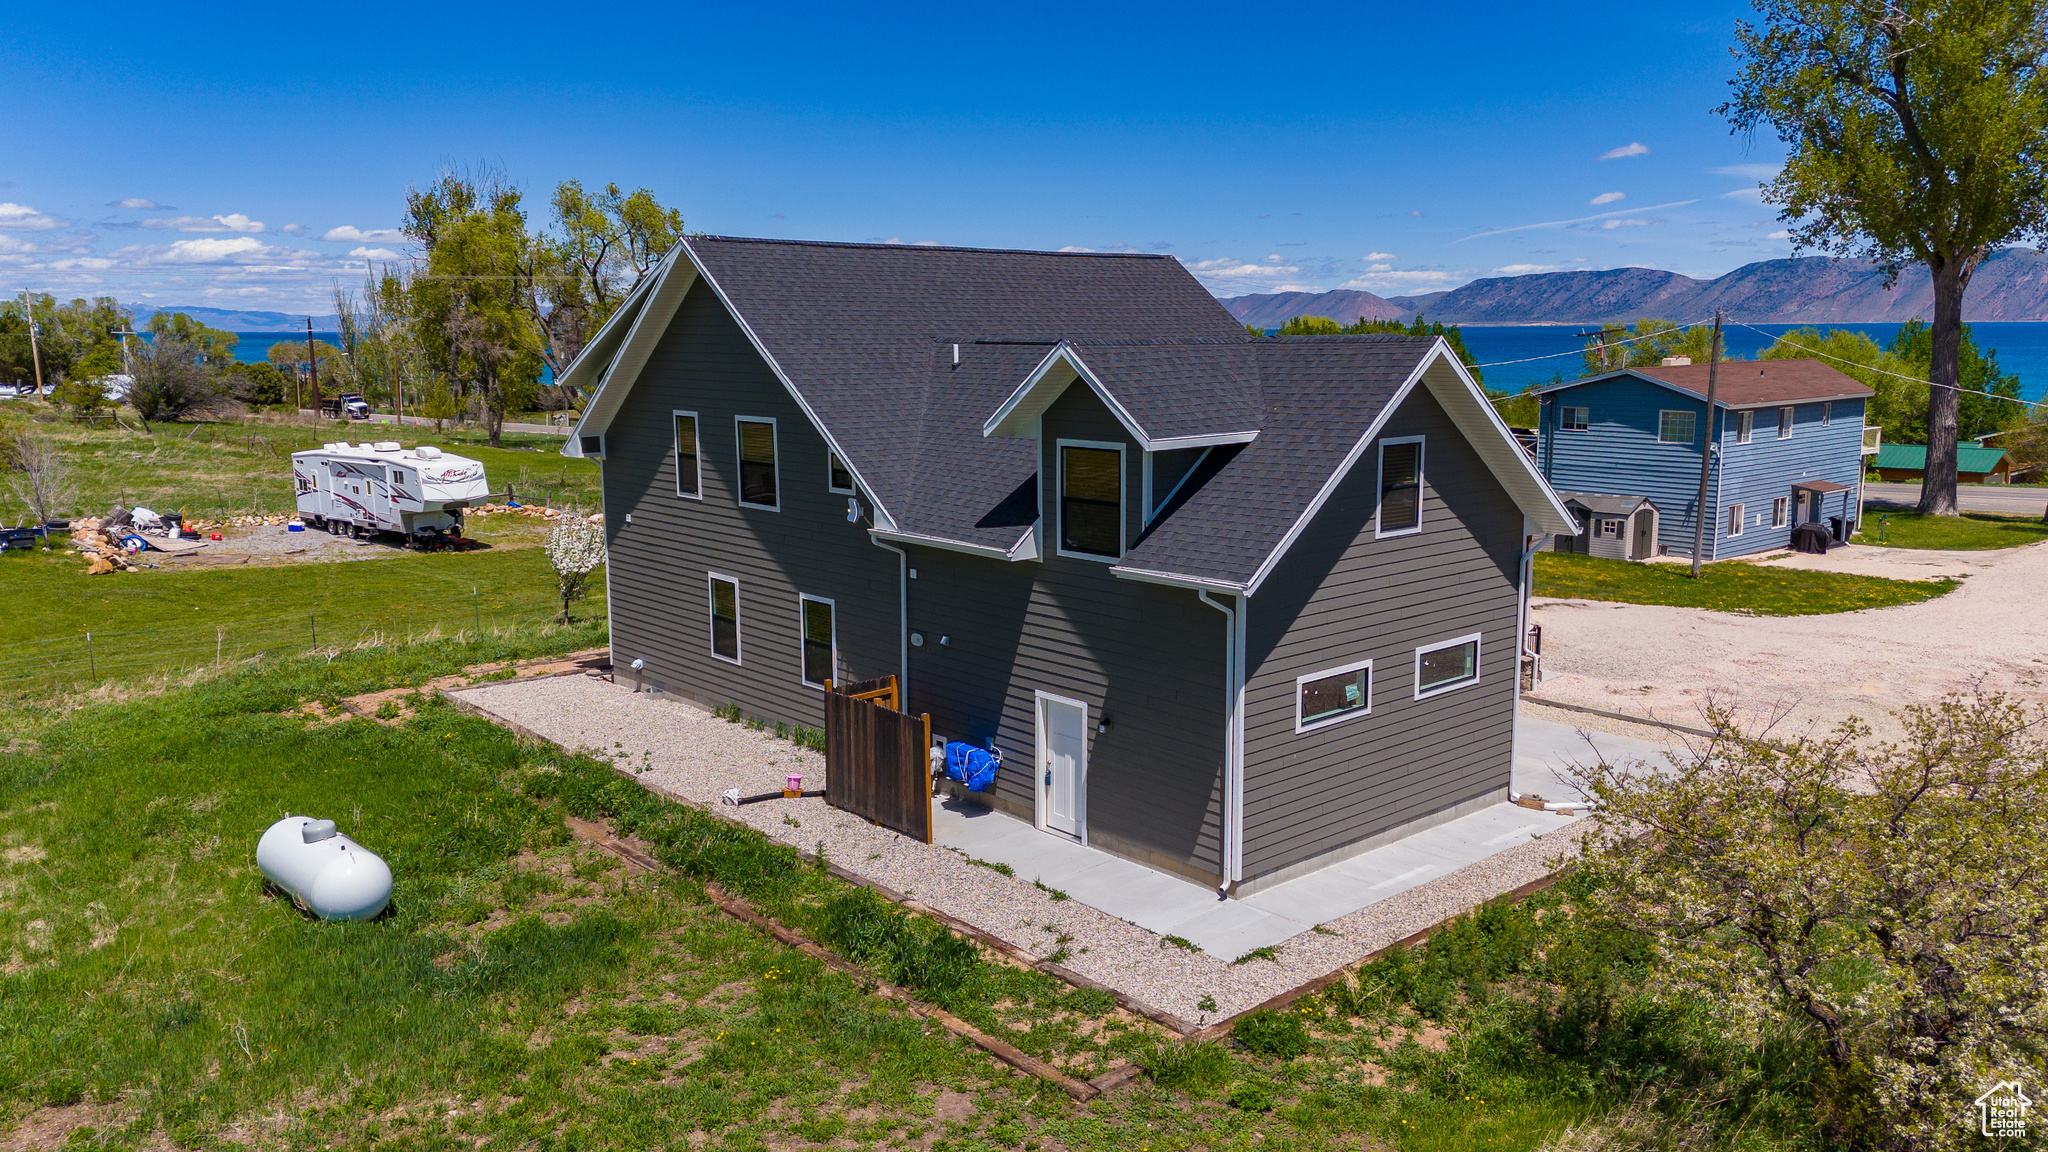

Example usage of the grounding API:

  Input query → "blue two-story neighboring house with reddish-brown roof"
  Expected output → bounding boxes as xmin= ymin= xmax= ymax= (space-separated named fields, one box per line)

xmin=1536 ymin=359 xmax=1876 ymax=560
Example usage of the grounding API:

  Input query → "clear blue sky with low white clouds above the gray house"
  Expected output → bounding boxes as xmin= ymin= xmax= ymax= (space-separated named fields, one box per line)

xmin=0 ymin=0 xmax=1790 ymax=312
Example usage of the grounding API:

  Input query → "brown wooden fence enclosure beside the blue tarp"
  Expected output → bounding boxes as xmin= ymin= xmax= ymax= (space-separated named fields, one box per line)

xmin=825 ymin=676 xmax=932 ymax=845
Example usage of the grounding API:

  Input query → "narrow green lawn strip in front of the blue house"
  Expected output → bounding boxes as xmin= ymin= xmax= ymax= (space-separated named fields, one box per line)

xmin=1534 ymin=551 xmax=1956 ymax=617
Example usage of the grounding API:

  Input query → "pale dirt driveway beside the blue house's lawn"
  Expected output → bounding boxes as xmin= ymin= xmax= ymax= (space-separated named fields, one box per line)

xmin=1534 ymin=543 xmax=2048 ymax=734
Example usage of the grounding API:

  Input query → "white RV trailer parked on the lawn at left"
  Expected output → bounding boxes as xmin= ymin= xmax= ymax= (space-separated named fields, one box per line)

xmin=291 ymin=441 xmax=492 ymax=547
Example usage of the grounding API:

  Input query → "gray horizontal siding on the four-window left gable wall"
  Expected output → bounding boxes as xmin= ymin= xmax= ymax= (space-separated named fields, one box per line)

xmin=604 ymin=281 xmax=901 ymax=726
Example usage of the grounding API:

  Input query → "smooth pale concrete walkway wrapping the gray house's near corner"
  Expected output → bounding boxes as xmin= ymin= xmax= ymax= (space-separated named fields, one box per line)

xmin=934 ymin=717 xmax=1665 ymax=959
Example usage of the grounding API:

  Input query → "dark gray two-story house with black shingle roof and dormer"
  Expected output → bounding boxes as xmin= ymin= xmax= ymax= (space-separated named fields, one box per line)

xmin=563 ymin=238 xmax=1573 ymax=892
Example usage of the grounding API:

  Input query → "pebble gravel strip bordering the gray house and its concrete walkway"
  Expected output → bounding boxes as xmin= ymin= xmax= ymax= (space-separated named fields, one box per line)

xmin=449 ymin=676 xmax=1577 ymax=1025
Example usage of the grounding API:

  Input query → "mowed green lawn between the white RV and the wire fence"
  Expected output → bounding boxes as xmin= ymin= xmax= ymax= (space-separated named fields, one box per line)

xmin=0 ymin=537 xmax=604 ymax=699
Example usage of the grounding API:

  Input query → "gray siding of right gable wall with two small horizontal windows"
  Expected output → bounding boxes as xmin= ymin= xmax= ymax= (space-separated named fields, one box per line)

xmin=1245 ymin=389 xmax=1522 ymax=879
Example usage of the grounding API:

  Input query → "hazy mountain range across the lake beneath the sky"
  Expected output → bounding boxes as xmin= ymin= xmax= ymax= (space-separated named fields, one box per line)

xmin=1223 ymin=248 xmax=2048 ymax=328
